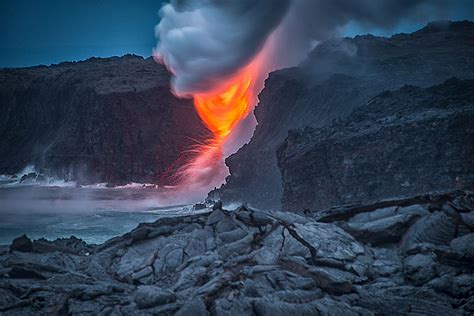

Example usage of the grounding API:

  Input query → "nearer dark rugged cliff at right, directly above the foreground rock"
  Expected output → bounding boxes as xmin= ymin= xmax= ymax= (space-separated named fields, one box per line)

xmin=277 ymin=79 xmax=474 ymax=211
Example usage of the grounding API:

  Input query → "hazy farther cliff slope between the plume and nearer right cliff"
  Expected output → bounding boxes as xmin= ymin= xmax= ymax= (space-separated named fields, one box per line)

xmin=210 ymin=22 xmax=474 ymax=208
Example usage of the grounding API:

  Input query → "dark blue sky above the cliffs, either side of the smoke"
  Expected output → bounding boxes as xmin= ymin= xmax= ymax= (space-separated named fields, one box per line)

xmin=0 ymin=0 xmax=474 ymax=67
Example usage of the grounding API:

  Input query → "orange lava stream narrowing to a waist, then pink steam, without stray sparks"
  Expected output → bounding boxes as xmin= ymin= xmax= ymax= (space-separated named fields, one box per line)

xmin=170 ymin=57 xmax=259 ymax=198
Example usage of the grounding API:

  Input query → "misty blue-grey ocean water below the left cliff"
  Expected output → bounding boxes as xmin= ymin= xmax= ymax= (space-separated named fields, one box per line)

xmin=0 ymin=185 xmax=202 ymax=245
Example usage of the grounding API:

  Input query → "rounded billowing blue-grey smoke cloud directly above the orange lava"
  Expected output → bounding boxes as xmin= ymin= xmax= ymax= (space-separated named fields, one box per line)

xmin=155 ymin=0 xmax=290 ymax=95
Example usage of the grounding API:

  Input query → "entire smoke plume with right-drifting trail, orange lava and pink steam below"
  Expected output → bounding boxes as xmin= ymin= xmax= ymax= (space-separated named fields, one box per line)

xmin=154 ymin=0 xmax=472 ymax=197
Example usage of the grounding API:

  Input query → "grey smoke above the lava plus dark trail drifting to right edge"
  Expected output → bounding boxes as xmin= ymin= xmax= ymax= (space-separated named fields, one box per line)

xmin=156 ymin=0 xmax=474 ymax=94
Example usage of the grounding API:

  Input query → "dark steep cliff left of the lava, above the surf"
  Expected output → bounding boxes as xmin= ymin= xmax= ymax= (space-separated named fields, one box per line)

xmin=0 ymin=56 xmax=209 ymax=184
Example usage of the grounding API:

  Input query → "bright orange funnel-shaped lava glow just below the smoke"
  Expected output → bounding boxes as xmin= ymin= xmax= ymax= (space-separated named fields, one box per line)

xmin=194 ymin=58 xmax=259 ymax=142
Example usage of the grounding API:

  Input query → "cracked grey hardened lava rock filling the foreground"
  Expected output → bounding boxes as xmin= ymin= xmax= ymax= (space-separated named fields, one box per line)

xmin=0 ymin=191 xmax=474 ymax=316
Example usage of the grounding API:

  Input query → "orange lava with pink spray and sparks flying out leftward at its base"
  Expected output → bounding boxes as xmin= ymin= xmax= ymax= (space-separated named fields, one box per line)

xmin=160 ymin=54 xmax=264 ymax=201
